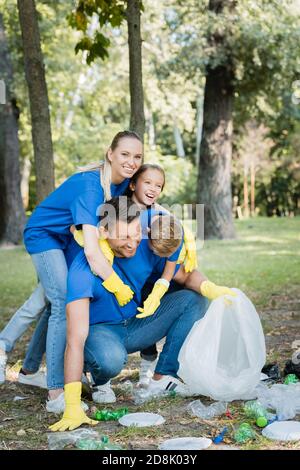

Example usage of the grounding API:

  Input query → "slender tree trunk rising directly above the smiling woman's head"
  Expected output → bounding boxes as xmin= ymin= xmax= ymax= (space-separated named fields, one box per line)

xmin=126 ymin=0 xmax=145 ymax=139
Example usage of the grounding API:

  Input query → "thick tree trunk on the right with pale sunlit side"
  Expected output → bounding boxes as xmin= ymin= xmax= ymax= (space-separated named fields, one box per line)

xmin=198 ymin=0 xmax=235 ymax=239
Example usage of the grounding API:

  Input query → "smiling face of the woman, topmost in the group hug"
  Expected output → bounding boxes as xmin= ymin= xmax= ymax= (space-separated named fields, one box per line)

xmin=107 ymin=137 xmax=143 ymax=184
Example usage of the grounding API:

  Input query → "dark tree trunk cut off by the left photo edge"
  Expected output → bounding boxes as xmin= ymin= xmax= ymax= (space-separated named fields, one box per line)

xmin=0 ymin=14 xmax=25 ymax=244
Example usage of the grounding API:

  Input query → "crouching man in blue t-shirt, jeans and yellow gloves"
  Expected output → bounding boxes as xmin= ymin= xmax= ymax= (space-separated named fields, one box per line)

xmin=51 ymin=198 xmax=208 ymax=431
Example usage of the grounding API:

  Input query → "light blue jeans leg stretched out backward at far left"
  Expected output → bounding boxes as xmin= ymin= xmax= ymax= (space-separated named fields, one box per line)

xmin=0 ymin=283 xmax=47 ymax=352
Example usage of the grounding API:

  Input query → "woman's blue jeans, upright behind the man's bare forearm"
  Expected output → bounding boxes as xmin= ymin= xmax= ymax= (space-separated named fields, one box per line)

xmin=24 ymin=250 xmax=68 ymax=390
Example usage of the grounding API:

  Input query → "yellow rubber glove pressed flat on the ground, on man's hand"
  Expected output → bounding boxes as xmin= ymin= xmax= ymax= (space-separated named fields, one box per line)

xmin=49 ymin=382 xmax=98 ymax=431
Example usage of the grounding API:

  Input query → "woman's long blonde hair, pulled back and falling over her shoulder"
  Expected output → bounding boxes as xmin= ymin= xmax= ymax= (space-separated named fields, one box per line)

xmin=78 ymin=131 xmax=142 ymax=201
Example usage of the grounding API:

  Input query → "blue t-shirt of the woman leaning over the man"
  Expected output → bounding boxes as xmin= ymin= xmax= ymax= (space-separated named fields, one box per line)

xmin=24 ymin=170 xmax=129 ymax=254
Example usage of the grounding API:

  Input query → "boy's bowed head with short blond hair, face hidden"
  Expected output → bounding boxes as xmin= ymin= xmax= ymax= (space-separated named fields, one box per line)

xmin=149 ymin=214 xmax=183 ymax=258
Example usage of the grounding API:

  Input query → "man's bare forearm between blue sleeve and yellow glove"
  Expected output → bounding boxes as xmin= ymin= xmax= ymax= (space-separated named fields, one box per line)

xmin=65 ymin=299 xmax=90 ymax=384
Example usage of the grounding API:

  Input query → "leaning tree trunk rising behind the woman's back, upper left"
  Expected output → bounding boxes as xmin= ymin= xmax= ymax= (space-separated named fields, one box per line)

xmin=18 ymin=0 xmax=54 ymax=203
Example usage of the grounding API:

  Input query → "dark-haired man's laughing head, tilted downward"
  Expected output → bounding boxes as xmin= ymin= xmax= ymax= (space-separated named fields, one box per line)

xmin=99 ymin=196 xmax=142 ymax=258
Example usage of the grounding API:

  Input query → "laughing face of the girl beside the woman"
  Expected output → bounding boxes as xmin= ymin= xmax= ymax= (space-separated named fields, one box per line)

xmin=130 ymin=168 xmax=165 ymax=206
